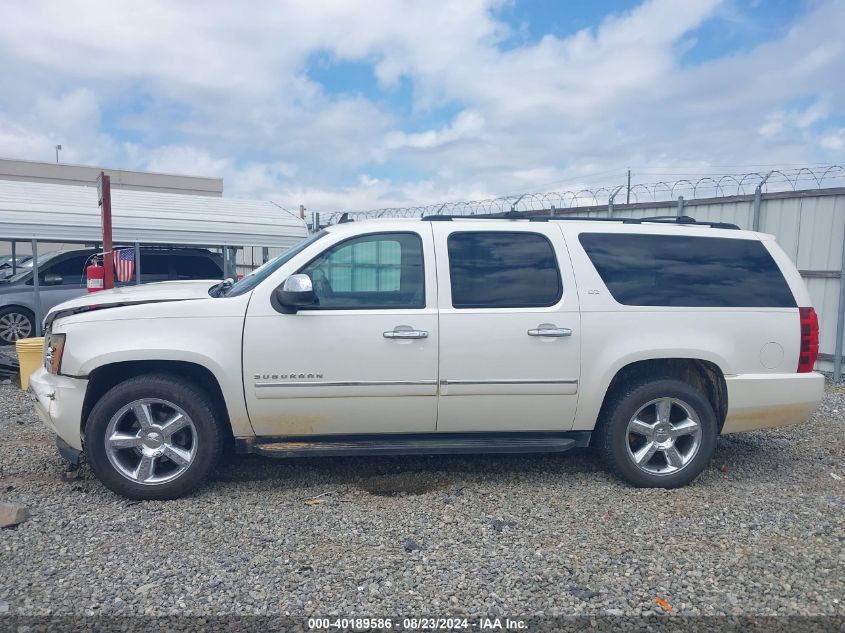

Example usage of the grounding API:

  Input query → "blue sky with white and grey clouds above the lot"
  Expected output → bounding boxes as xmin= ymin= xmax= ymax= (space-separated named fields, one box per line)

xmin=0 ymin=0 xmax=845 ymax=210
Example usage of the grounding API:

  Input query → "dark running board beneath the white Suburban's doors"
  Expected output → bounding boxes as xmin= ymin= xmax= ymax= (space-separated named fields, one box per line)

xmin=237 ymin=432 xmax=590 ymax=458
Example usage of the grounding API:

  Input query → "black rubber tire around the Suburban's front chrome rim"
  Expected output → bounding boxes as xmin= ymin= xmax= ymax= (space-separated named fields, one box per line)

xmin=85 ymin=374 xmax=224 ymax=499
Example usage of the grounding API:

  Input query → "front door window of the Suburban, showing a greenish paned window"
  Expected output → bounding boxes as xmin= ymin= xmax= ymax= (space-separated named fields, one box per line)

xmin=300 ymin=233 xmax=425 ymax=310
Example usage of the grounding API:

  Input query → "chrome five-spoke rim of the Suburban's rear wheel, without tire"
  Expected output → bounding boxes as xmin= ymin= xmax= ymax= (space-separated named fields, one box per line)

xmin=627 ymin=398 xmax=701 ymax=475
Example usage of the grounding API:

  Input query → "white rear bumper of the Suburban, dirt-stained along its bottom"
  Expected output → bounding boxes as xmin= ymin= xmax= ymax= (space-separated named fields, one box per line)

xmin=722 ymin=372 xmax=824 ymax=434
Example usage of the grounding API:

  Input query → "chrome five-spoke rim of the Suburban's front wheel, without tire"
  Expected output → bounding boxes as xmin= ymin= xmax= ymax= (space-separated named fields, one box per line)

xmin=104 ymin=398 xmax=197 ymax=485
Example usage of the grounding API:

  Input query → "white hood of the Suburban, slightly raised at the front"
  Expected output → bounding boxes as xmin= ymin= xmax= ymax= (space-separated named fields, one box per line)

xmin=44 ymin=279 xmax=219 ymax=327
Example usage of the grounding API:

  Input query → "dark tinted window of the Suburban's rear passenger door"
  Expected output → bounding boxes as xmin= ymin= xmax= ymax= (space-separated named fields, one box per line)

xmin=447 ymin=231 xmax=562 ymax=308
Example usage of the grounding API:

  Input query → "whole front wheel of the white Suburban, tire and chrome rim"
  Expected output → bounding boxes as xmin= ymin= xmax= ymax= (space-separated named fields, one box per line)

xmin=85 ymin=374 xmax=223 ymax=499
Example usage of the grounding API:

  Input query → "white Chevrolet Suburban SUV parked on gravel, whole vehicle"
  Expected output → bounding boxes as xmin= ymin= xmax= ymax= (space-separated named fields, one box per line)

xmin=30 ymin=214 xmax=824 ymax=499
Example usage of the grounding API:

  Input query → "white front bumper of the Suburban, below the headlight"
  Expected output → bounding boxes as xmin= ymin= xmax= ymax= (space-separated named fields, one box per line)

xmin=27 ymin=367 xmax=88 ymax=451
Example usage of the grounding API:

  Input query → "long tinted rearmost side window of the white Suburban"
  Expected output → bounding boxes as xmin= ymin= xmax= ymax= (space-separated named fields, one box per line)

xmin=578 ymin=233 xmax=796 ymax=308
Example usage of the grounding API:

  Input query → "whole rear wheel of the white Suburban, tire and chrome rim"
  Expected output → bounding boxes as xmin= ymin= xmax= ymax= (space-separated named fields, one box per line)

xmin=597 ymin=379 xmax=718 ymax=488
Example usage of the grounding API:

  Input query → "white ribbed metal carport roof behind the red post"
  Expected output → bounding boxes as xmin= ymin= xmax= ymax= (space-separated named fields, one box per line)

xmin=0 ymin=181 xmax=308 ymax=248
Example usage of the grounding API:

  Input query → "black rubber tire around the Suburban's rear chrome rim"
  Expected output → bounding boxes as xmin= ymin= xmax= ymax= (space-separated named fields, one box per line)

xmin=595 ymin=379 xmax=718 ymax=488
